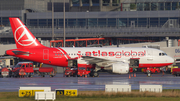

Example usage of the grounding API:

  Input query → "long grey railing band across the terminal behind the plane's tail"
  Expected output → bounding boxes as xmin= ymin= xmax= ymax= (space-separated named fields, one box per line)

xmin=0 ymin=27 xmax=180 ymax=38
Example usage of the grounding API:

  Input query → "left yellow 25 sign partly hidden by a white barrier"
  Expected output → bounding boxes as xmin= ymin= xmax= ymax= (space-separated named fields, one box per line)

xmin=19 ymin=89 xmax=44 ymax=97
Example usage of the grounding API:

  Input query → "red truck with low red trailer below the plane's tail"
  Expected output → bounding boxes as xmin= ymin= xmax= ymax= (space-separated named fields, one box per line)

xmin=12 ymin=62 xmax=55 ymax=77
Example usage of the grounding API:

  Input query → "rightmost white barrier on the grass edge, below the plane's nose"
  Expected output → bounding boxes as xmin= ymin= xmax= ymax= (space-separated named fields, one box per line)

xmin=139 ymin=85 xmax=162 ymax=93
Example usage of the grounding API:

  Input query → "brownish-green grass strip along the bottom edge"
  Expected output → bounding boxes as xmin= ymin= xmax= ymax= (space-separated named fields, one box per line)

xmin=0 ymin=90 xmax=180 ymax=101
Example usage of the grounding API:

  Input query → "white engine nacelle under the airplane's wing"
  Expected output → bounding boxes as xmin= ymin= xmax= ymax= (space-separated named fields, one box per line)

xmin=112 ymin=63 xmax=129 ymax=74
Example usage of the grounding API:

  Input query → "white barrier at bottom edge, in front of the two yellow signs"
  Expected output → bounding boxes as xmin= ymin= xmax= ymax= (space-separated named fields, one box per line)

xmin=35 ymin=92 xmax=56 ymax=101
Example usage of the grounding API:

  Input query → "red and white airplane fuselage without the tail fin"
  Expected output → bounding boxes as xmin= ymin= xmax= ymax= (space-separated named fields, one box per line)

xmin=7 ymin=47 xmax=173 ymax=68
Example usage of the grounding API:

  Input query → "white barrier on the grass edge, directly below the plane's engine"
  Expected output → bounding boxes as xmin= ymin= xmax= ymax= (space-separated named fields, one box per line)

xmin=105 ymin=85 xmax=131 ymax=92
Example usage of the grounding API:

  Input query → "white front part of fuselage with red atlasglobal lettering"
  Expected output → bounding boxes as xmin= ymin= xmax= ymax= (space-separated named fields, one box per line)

xmin=62 ymin=47 xmax=174 ymax=67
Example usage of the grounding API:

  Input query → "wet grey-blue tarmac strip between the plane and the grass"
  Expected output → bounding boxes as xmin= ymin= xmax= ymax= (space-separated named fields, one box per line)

xmin=0 ymin=73 xmax=180 ymax=92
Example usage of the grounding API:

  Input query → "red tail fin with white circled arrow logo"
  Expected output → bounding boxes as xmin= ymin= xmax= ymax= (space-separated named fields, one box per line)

xmin=9 ymin=18 xmax=44 ymax=48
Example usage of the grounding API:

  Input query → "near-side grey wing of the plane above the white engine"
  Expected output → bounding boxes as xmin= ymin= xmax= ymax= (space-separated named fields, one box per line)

xmin=82 ymin=56 xmax=120 ymax=67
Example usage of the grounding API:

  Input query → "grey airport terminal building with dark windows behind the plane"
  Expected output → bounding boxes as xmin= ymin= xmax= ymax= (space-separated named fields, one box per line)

xmin=0 ymin=0 xmax=180 ymax=44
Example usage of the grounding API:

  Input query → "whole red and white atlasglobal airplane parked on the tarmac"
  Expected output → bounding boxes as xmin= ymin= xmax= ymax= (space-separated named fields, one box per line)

xmin=6 ymin=18 xmax=174 ymax=77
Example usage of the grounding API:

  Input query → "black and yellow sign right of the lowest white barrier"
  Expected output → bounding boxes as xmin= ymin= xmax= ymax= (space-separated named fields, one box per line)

xmin=56 ymin=89 xmax=78 ymax=96
